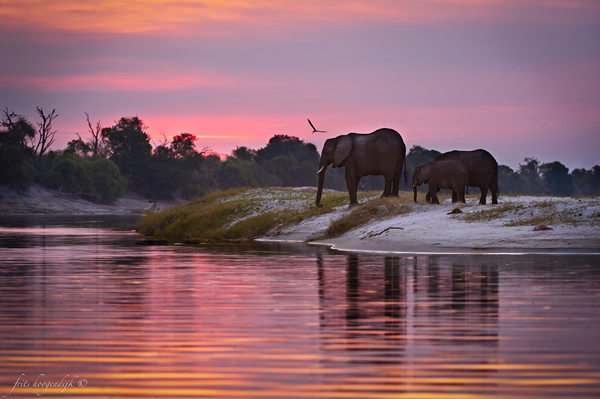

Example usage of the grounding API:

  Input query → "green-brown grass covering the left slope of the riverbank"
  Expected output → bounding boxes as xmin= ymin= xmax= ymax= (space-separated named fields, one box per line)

xmin=138 ymin=187 xmax=412 ymax=241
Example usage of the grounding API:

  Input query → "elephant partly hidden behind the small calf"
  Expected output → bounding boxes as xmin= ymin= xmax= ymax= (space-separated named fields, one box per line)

xmin=433 ymin=149 xmax=498 ymax=205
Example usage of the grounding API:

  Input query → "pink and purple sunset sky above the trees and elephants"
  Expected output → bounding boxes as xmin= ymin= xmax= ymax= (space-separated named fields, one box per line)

xmin=0 ymin=0 xmax=600 ymax=169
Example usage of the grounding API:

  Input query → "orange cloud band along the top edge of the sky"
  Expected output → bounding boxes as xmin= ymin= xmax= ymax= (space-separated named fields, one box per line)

xmin=0 ymin=0 xmax=599 ymax=35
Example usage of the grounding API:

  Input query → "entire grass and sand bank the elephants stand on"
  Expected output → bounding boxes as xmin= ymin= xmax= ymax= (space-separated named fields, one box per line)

xmin=138 ymin=187 xmax=600 ymax=250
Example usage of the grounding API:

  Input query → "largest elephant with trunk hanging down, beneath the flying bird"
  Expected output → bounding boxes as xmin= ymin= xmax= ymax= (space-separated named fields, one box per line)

xmin=316 ymin=128 xmax=408 ymax=206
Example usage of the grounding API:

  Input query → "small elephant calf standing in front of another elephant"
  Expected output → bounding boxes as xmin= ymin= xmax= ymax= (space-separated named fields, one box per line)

xmin=412 ymin=160 xmax=468 ymax=204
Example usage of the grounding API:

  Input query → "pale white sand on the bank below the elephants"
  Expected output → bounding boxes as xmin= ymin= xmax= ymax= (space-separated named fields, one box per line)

xmin=262 ymin=192 xmax=600 ymax=253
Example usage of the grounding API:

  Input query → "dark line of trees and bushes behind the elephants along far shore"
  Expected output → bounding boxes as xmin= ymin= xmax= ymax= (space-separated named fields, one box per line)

xmin=0 ymin=108 xmax=600 ymax=203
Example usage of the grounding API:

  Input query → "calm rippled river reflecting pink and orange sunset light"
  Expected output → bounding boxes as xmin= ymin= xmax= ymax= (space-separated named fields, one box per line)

xmin=0 ymin=217 xmax=600 ymax=398
